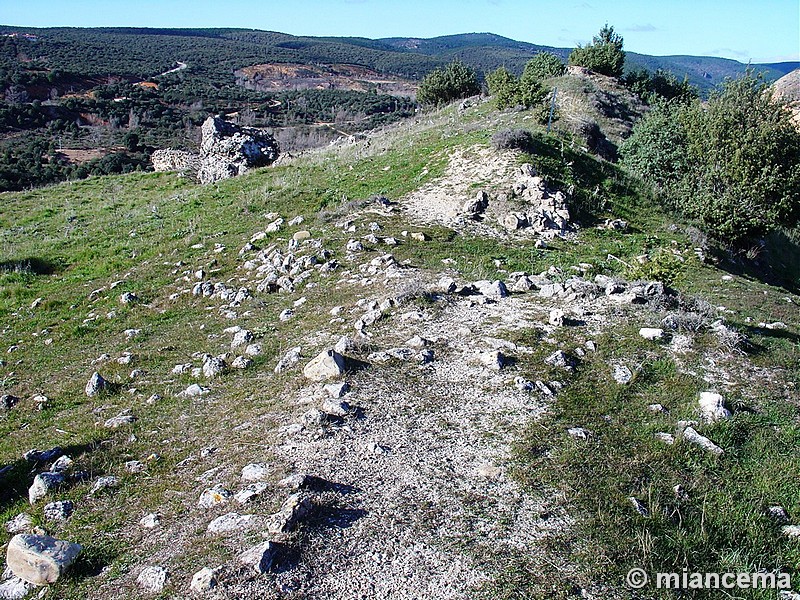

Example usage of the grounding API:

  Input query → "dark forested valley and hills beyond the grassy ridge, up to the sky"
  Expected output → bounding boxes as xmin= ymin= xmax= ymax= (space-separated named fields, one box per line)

xmin=0 ymin=26 xmax=791 ymax=191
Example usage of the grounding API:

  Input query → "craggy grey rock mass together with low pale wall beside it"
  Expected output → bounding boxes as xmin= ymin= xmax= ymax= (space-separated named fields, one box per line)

xmin=152 ymin=116 xmax=279 ymax=184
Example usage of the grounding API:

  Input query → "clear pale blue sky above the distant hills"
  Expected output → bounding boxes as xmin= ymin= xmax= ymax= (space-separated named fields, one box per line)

xmin=0 ymin=0 xmax=800 ymax=62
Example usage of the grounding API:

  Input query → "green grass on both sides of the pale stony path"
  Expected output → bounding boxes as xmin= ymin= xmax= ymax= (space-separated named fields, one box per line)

xmin=0 ymin=98 xmax=800 ymax=598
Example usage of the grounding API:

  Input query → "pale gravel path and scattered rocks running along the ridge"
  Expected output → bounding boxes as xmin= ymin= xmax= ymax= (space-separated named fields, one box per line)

xmin=0 ymin=96 xmax=791 ymax=600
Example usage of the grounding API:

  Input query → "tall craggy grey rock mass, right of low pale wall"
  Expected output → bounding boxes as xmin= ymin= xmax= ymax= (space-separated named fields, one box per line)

xmin=197 ymin=117 xmax=278 ymax=183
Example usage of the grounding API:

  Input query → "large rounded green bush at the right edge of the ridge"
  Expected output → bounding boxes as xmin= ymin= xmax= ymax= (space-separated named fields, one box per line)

xmin=621 ymin=72 xmax=800 ymax=245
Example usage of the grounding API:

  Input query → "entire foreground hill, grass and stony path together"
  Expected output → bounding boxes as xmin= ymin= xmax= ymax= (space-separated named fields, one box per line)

xmin=0 ymin=64 xmax=800 ymax=599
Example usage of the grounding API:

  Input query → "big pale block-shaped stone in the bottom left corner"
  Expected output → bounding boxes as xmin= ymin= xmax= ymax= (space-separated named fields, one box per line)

xmin=6 ymin=534 xmax=81 ymax=585
